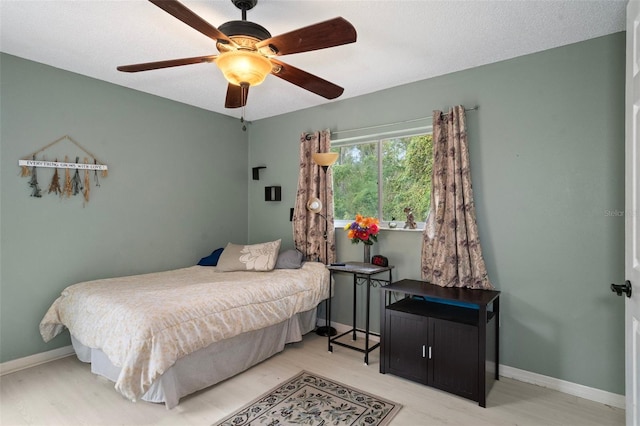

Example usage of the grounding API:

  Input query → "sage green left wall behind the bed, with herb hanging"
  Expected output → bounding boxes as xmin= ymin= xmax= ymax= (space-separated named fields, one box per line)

xmin=0 ymin=54 xmax=249 ymax=362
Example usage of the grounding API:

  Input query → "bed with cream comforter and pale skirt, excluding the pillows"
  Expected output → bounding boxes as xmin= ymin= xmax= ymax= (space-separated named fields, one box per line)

xmin=40 ymin=248 xmax=329 ymax=408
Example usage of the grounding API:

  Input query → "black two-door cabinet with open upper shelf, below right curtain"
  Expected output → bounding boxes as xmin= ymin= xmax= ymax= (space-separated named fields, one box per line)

xmin=380 ymin=280 xmax=500 ymax=407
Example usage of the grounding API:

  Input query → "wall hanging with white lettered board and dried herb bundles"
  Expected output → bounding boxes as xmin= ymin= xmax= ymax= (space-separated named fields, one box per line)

xmin=18 ymin=135 xmax=108 ymax=203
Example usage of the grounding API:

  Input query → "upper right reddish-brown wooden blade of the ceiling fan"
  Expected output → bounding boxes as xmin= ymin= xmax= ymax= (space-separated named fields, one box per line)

xmin=255 ymin=17 xmax=357 ymax=56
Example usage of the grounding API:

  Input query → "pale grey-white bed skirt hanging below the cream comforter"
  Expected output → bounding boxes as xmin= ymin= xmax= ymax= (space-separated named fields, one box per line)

xmin=71 ymin=309 xmax=317 ymax=408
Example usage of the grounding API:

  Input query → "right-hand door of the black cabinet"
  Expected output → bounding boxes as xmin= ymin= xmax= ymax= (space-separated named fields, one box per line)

xmin=428 ymin=318 xmax=484 ymax=401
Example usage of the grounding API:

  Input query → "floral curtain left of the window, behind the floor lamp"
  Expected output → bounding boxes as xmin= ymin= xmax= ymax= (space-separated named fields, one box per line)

xmin=293 ymin=130 xmax=336 ymax=264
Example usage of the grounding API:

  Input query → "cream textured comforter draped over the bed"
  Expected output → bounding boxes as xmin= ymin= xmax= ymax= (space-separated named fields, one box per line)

xmin=40 ymin=262 xmax=329 ymax=400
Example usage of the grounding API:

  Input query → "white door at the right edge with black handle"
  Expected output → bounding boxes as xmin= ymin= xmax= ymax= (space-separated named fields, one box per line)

xmin=625 ymin=0 xmax=640 ymax=426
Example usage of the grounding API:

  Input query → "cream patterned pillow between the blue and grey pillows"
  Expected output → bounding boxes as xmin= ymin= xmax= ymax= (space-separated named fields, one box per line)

xmin=217 ymin=240 xmax=282 ymax=272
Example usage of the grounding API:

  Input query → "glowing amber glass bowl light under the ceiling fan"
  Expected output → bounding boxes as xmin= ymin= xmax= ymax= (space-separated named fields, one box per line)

xmin=216 ymin=49 xmax=272 ymax=86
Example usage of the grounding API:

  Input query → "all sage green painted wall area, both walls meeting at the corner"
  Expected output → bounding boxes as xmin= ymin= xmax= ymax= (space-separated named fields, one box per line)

xmin=0 ymin=33 xmax=625 ymax=394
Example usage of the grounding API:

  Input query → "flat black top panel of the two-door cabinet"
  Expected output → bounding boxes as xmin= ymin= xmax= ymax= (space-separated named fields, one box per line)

xmin=381 ymin=280 xmax=500 ymax=305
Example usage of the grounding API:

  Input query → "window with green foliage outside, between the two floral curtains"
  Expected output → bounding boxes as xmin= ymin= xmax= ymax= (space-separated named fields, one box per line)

xmin=331 ymin=133 xmax=433 ymax=227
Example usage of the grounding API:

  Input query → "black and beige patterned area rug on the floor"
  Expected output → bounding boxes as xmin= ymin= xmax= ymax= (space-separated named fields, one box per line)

xmin=214 ymin=371 xmax=402 ymax=426
